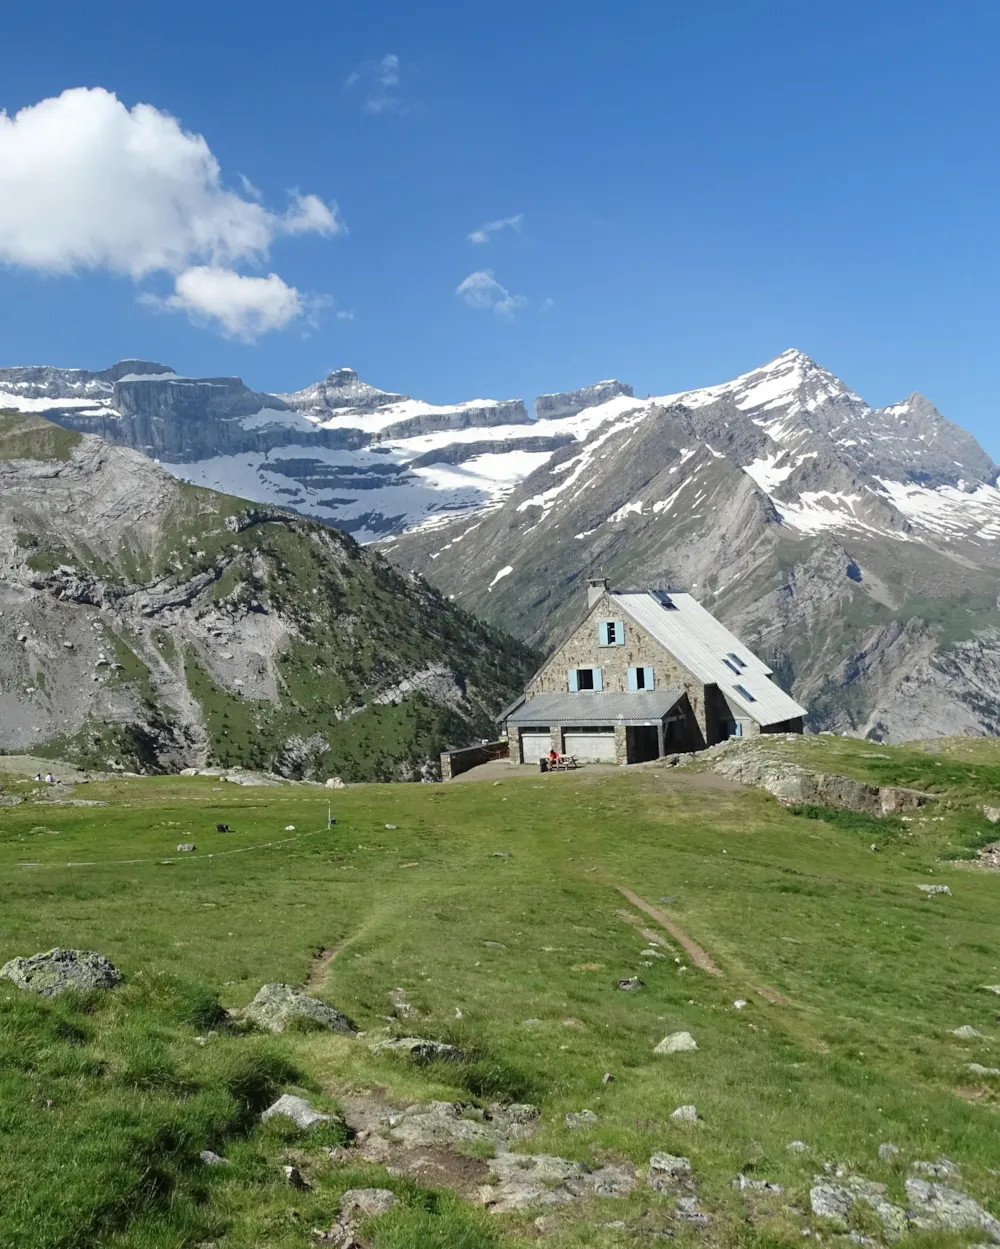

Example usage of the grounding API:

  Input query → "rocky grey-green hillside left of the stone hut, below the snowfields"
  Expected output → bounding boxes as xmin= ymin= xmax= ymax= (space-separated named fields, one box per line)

xmin=0 ymin=415 xmax=534 ymax=779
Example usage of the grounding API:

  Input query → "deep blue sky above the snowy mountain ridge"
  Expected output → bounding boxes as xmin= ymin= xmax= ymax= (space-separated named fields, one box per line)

xmin=0 ymin=0 xmax=1000 ymax=457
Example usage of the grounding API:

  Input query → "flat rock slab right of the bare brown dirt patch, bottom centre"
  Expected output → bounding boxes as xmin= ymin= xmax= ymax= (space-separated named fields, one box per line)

xmin=479 ymin=1153 xmax=637 ymax=1214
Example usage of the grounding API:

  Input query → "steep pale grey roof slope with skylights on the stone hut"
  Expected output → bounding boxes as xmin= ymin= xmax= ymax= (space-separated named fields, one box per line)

xmin=610 ymin=591 xmax=806 ymax=724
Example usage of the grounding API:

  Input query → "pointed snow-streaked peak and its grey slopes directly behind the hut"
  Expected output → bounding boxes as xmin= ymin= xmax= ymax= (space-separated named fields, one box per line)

xmin=385 ymin=351 xmax=1000 ymax=739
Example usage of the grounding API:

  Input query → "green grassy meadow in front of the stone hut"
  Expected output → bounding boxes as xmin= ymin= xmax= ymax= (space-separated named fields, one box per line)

xmin=0 ymin=738 xmax=1000 ymax=1249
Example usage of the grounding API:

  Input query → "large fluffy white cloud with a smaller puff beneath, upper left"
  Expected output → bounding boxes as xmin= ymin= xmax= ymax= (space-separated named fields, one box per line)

xmin=0 ymin=87 xmax=345 ymax=336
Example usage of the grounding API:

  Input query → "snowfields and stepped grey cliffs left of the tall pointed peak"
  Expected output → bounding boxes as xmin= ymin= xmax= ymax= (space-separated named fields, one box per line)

xmin=0 ymin=361 xmax=634 ymax=542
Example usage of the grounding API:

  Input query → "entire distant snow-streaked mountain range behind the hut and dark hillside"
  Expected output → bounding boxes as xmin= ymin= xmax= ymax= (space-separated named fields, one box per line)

xmin=0 ymin=348 xmax=1000 ymax=739
